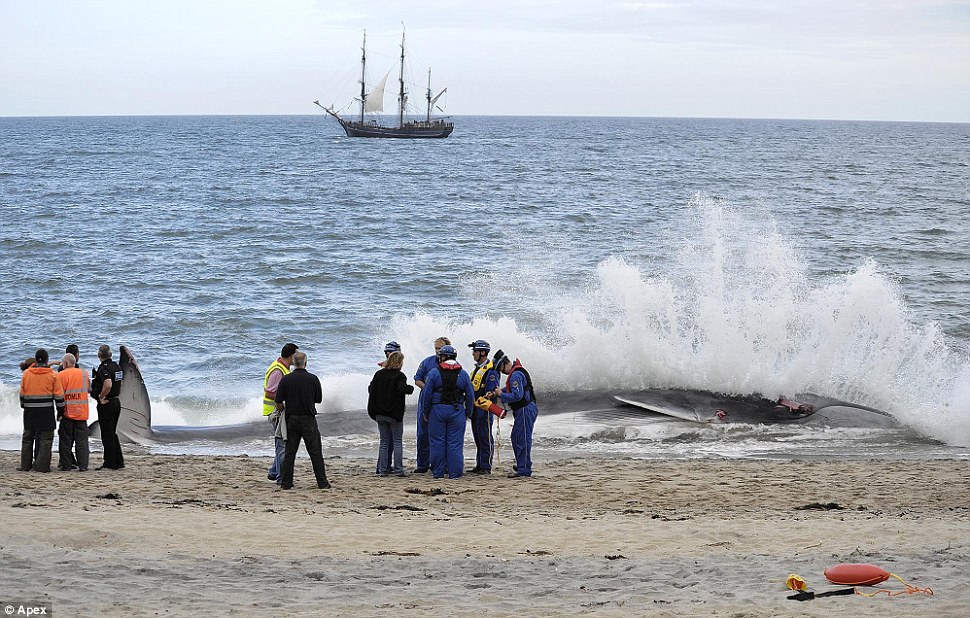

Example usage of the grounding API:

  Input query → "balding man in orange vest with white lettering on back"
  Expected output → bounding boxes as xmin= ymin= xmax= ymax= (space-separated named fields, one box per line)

xmin=57 ymin=353 xmax=91 ymax=472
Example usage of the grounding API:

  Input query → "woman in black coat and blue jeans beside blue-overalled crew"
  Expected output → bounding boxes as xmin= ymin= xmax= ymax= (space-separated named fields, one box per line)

xmin=367 ymin=352 xmax=414 ymax=476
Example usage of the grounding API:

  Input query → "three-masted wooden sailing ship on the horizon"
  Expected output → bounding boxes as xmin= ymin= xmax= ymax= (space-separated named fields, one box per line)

xmin=313 ymin=32 xmax=455 ymax=139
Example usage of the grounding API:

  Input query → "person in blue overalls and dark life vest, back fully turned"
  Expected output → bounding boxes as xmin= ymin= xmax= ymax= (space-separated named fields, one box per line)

xmin=418 ymin=345 xmax=475 ymax=479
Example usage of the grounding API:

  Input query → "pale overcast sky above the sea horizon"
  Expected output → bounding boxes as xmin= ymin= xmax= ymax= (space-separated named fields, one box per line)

xmin=0 ymin=0 xmax=970 ymax=122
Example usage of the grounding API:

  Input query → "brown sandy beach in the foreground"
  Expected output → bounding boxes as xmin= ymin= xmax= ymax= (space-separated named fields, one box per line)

xmin=0 ymin=452 xmax=970 ymax=618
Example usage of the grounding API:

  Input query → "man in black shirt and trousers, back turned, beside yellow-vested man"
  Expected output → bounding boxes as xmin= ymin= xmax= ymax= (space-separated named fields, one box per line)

xmin=276 ymin=352 xmax=330 ymax=489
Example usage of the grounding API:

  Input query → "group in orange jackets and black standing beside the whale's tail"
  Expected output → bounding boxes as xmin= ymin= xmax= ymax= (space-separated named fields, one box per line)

xmin=17 ymin=344 xmax=125 ymax=472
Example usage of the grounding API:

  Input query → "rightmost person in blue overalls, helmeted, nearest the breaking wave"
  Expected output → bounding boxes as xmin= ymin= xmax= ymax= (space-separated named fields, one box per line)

xmin=492 ymin=350 xmax=539 ymax=478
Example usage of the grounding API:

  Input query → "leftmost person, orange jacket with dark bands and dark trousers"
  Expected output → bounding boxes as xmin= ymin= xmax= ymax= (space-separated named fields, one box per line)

xmin=17 ymin=348 xmax=64 ymax=472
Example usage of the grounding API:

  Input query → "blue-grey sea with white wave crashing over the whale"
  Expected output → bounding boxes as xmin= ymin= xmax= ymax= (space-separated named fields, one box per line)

xmin=0 ymin=115 xmax=970 ymax=457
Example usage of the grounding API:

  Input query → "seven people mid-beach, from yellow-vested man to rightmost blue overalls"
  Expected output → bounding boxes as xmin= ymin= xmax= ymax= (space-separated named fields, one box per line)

xmin=263 ymin=337 xmax=539 ymax=489
